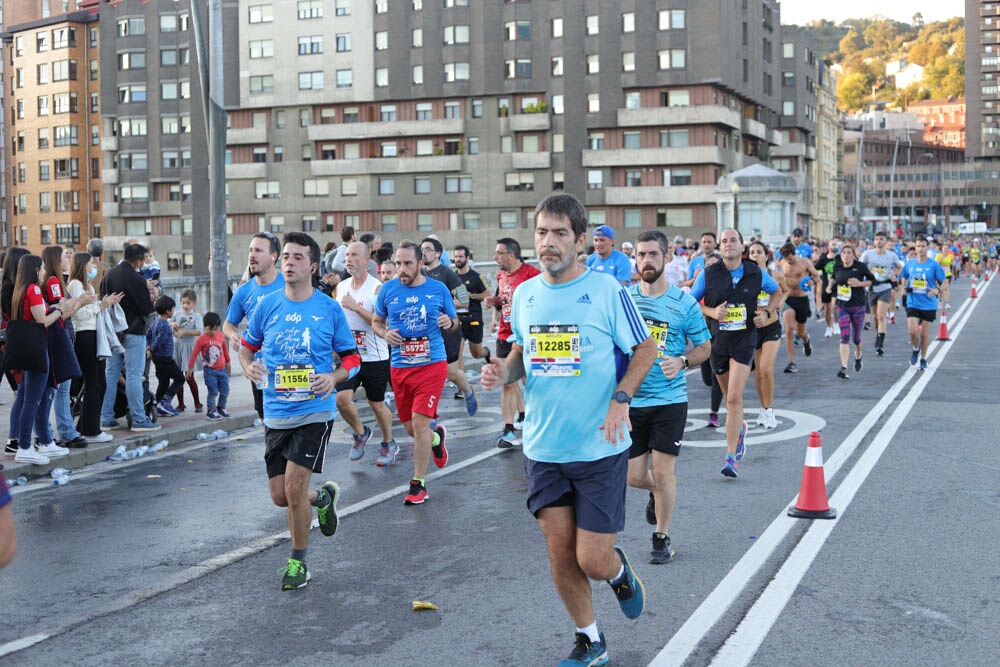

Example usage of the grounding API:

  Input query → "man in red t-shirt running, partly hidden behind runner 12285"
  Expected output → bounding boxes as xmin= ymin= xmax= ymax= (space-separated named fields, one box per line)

xmin=484 ymin=237 xmax=541 ymax=449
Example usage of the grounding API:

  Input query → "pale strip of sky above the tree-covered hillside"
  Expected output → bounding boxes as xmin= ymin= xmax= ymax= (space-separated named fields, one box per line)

xmin=781 ymin=0 xmax=965 ymax=25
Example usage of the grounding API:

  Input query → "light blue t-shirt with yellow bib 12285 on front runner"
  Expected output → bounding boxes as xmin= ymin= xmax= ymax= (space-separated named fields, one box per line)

xmin=510 ymin=270 xmax=649 ymax=463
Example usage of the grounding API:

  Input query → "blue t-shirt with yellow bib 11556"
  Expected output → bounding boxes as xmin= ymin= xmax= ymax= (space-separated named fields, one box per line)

xmin=243 ymin=290 xmax=357 ymax=423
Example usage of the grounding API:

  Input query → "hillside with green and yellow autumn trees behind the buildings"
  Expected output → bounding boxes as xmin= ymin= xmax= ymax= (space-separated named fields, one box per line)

xmin=806 ymin=13 xmax=965 ymax=111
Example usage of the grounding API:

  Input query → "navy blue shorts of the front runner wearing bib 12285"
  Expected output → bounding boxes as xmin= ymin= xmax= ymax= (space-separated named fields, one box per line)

xmin=524 ymin=450 xmax=628 ymax=534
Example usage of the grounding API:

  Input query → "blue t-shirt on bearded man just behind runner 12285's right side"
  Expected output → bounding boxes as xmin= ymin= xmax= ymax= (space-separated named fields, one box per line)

xmin=628 ymin=285 xmax=712 ymax=408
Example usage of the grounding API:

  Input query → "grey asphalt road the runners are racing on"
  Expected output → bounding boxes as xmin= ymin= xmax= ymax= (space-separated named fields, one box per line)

xmin=0 ymin=280 xmax=1000 ymax=666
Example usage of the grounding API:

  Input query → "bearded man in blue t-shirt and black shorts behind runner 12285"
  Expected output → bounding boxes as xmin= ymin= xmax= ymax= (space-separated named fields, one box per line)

xmin=628 ymin=229 xmax=712 ymax=565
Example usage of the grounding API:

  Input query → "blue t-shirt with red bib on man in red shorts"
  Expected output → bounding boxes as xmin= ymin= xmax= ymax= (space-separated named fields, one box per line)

xmin=375 ymin=278 xmax=457 ymax=368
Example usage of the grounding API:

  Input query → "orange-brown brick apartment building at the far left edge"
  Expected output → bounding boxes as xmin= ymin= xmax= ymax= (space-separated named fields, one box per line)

xmin=3 ymin=2 xmax=103 ymax=252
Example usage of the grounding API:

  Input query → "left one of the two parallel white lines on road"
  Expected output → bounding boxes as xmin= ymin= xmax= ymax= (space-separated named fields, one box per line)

xmin=649 ymin=284 xmax=985 ymax=667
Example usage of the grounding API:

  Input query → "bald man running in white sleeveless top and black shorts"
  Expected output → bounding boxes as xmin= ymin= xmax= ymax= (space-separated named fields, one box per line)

xmin=337 ymin=241 xmax=399 ymax=466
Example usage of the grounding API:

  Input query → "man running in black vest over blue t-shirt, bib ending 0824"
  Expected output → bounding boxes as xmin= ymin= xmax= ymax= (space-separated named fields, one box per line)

xmin=691 ymin=229 xmax=780 ymax=478
